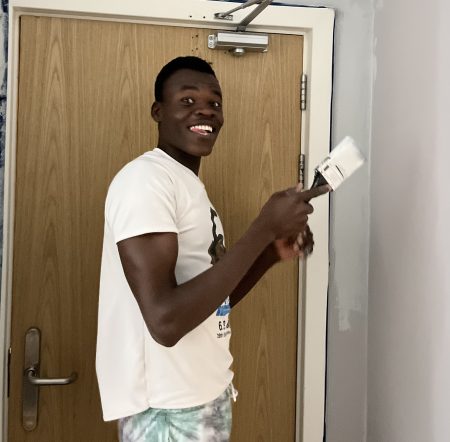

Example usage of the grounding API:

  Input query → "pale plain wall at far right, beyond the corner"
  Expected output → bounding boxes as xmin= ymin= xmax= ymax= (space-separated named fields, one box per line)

xmin=367 ymin=0 xmax=450 ymax=442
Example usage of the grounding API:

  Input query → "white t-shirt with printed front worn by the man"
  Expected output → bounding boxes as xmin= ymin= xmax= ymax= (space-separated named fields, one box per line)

xmin=96 ymin=149 xmax=233 ymax=420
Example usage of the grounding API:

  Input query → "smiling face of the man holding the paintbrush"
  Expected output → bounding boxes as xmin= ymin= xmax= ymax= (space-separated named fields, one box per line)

xmin=152 ymin=69 xmax=223 ymax=167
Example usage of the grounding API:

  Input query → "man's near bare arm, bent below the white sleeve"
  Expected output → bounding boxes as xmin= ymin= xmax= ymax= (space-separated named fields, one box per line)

xmin=118 ymin=188 xmax=328 ymax=346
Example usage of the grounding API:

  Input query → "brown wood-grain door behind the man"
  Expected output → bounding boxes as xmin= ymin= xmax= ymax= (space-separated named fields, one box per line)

xmin=9 ymin=17 xmax=302 ymax=442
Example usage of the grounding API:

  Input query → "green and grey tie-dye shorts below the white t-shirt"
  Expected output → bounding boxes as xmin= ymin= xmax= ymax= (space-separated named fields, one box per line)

xmin=119 ymin=385 xmax=236 ymax=442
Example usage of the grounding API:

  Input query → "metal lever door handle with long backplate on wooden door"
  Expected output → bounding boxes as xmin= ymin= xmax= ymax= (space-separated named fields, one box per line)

xmin=22 ymin=327 xmax=78 ymax=431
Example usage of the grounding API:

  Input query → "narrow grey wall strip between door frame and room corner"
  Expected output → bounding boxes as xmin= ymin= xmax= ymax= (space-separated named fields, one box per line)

xmin=285 ymin=0 xmax=372 ymax=442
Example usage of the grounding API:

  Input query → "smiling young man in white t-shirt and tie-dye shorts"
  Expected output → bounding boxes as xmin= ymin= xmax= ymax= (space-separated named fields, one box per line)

xmin=97 ymin=57 xmax=329 ymax=442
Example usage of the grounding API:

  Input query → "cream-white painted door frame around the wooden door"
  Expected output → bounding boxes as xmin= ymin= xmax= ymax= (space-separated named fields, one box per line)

xmin=0 ymin=0 xmax=335 ymax=442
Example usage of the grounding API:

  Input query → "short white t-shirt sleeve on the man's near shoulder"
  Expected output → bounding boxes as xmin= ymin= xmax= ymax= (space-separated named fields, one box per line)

xmin=105 ymin=163 xmax=178 ymax=243
